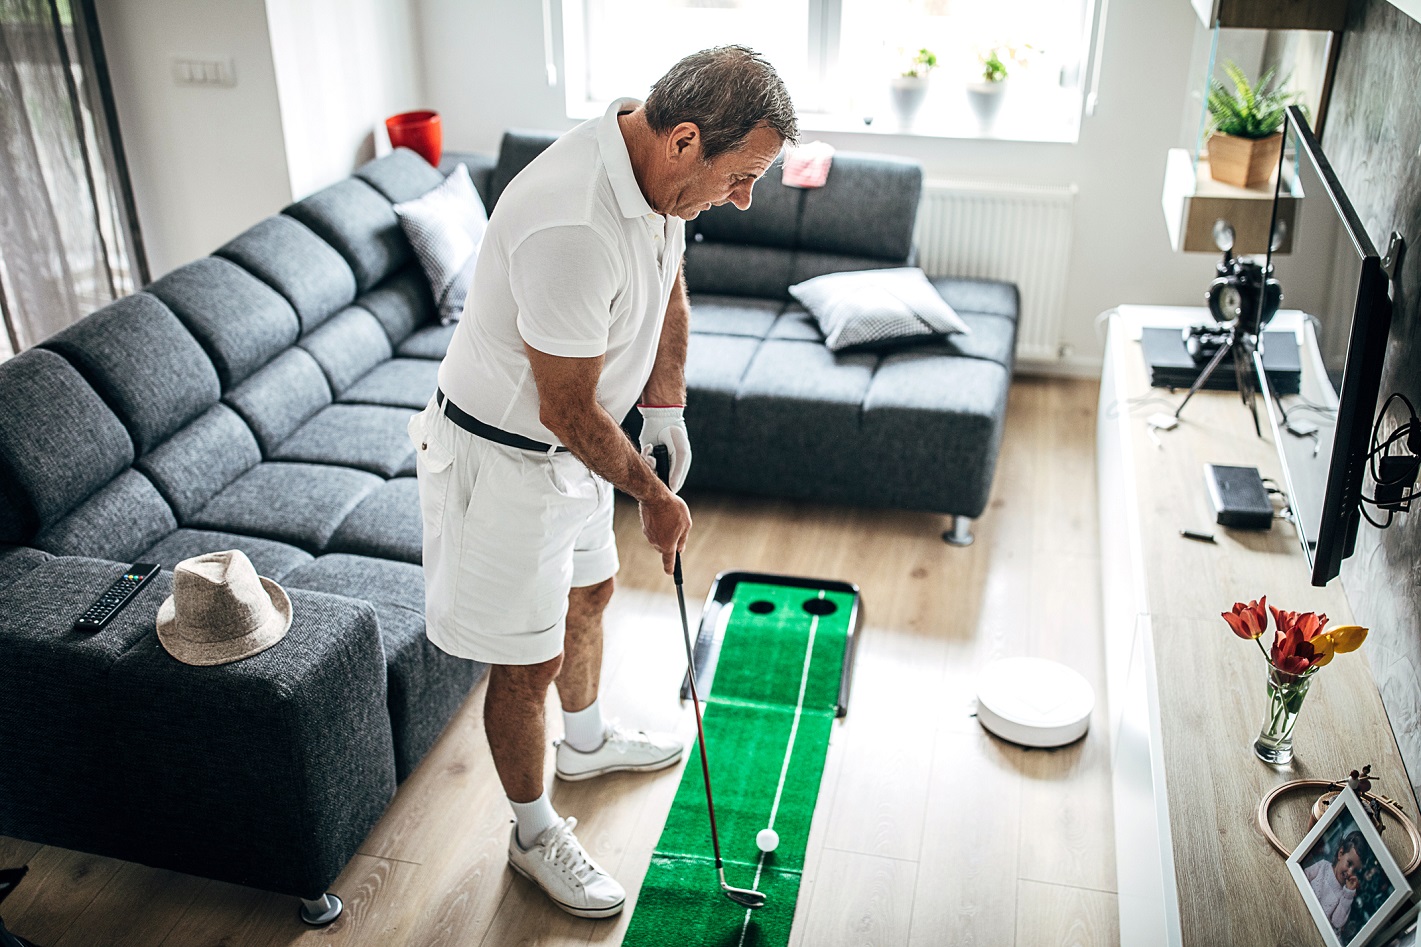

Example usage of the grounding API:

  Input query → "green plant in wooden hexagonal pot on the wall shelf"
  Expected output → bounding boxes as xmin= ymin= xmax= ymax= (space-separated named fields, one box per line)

xmin=1206 ymin=63 xmax=1297 ymax=188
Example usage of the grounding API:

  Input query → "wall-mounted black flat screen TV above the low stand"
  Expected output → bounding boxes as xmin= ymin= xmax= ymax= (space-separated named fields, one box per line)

xmin=1255 ymin=107 xmax=1391 ymax=586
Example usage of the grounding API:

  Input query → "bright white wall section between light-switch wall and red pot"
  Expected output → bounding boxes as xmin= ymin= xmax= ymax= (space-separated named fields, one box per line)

xmin=266 ymin=0 xmax=422 ymax=199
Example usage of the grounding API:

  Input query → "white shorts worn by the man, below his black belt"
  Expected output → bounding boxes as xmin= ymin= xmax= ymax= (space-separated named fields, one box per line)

xmin=409 ymin=389 xmax=618 ymax=664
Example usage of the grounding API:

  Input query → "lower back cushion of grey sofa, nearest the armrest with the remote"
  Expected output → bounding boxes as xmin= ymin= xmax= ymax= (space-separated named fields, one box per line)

xmin=31 ymin=469 xmax=178 ymax=562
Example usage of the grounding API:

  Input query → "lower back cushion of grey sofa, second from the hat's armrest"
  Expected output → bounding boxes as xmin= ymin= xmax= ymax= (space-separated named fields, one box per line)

xmin=134 ymin=404 xmax=261 ymax=523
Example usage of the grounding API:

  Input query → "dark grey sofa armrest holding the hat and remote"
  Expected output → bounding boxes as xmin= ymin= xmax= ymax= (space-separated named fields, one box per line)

xmin=0 ymin=557 xmax=395 ymax=897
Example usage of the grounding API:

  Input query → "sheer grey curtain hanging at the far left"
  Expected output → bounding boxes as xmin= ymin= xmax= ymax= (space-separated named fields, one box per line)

xmin=0 ymin=0 xmax=148 ymax=351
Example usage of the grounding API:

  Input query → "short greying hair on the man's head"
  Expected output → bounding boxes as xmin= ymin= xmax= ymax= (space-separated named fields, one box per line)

xmin=645 ymin=46 xmax=799 ymax=161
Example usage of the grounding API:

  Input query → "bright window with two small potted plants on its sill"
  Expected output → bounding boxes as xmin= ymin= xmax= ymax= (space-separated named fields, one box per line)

xmin=563 ymin=0 xmax=1096 ymax=141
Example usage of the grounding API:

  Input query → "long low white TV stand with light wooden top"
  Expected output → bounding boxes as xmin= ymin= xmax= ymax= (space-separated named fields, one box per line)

xmin=1097 ymin=306 xmax=1417 ymax=947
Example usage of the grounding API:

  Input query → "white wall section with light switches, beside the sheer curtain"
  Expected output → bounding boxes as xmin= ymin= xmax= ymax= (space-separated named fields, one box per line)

xmin=95 ymin=0 xmax=291 ymax=279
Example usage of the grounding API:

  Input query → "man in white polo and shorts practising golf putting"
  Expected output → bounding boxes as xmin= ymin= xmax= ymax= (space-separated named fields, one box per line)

xmin=411 ymin=47 xmax=797 ymax=917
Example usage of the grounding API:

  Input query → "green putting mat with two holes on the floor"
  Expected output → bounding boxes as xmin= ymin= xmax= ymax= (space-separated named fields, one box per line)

xmin=622 ymin=573 xmax=858 ymax=947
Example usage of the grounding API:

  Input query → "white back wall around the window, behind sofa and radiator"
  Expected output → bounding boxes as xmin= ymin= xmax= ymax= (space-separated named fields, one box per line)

xmin=416 ymin=0 xmax=1214 ymax=370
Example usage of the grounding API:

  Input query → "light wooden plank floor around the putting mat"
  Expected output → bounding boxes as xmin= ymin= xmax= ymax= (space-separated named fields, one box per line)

xmin=0 ymin=378 xmax=1118 ymax=947
